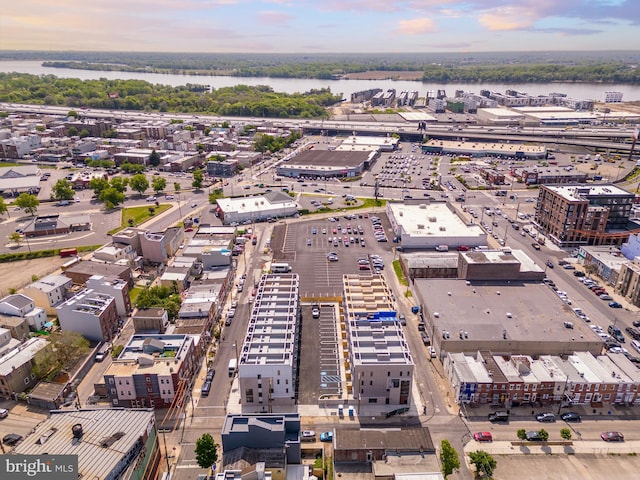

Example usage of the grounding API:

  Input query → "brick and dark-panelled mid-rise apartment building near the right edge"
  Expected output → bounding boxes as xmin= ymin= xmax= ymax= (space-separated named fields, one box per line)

xmin=535 ymin=185 xmax=637 ymax=247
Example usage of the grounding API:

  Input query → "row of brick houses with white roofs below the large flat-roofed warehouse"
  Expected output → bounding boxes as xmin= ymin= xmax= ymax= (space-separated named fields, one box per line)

xmin=444 ymin=351 xmax=640 ymax=408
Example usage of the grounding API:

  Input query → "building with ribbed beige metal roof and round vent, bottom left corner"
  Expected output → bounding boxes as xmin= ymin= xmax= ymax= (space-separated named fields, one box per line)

xmin=14 ymin=408 xmax=162 ymax=480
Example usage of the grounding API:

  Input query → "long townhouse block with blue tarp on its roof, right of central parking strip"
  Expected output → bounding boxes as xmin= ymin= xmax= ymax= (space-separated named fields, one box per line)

xmin=342 ymin=275 xmax=414 ymax=405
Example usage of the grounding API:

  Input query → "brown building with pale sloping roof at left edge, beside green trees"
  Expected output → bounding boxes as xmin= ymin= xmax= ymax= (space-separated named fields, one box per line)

xmin=0 ymin=337 xmax=49 ymax=399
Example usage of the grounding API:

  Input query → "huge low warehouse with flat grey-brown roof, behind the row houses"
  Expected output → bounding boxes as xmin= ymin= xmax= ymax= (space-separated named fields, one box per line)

xmin=414 ymin=279 xmax=603 ymax=358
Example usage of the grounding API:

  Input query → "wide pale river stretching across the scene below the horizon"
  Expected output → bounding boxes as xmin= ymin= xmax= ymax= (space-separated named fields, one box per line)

xmin=0 ymin=60 xmax=640 ymax=102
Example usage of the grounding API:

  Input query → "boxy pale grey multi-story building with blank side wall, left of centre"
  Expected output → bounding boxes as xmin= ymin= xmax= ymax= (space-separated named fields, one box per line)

xmin=56 ymin=288 xmax=118 ymax=342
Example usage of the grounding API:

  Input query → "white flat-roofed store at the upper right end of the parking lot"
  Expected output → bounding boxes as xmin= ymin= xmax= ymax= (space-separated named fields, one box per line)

xmin=386 ymin=202 xmax=487 ymax=250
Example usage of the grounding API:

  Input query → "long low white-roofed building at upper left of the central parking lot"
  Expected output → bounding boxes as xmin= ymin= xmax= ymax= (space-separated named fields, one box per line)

xmin=216 ymin=192 xmax=298 ymax=225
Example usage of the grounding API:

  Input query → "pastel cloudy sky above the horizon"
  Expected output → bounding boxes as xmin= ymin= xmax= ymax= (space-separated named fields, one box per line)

xmin=0 ymin=0 xmax=640 ymax=53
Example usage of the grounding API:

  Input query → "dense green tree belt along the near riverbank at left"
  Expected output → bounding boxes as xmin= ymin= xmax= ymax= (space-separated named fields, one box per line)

xmin=0 ymin=73 xmax=342 ymax=118
